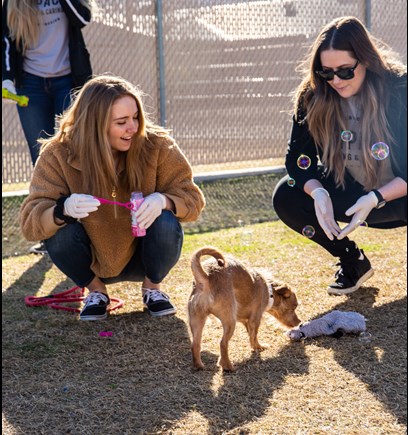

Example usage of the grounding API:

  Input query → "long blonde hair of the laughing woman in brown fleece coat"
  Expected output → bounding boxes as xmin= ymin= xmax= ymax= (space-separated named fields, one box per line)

xmin=40 ymin=75 xmax=172 ymax=195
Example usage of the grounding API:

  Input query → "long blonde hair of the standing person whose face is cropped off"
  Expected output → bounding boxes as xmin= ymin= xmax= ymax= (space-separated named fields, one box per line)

xmin=7 ymin=0 xmax=99 ymax=54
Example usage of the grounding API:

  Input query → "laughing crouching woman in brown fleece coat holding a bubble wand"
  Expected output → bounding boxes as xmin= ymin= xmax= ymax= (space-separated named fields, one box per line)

xmin=20 ymin=75 xmax=205 ymax=320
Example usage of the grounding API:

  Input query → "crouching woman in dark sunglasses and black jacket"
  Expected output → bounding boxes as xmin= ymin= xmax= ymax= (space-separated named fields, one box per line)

xmin=273 ymin=17 xmax=407 ymax=295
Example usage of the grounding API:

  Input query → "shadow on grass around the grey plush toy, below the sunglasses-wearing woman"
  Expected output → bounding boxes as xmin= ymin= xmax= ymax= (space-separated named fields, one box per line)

xmin=296 ymin=287 xmax=407 ymax=425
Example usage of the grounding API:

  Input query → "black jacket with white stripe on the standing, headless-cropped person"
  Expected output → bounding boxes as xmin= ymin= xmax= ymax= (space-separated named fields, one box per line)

xmin=2 ymin=0 xmax=92 ymax=88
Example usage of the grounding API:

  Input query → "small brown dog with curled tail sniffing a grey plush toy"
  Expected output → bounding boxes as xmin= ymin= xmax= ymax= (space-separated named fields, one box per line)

xmin=188 ymin=247 xmax=300 ymax=371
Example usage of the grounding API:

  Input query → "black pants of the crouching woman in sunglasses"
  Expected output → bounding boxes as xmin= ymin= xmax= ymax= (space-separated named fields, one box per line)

xmin=272 ymin=169 xmax=407 ymax=259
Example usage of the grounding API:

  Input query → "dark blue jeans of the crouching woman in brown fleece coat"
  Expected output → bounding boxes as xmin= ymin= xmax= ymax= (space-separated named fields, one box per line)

xmin=44 ymin=210 xmax=183 ymax=287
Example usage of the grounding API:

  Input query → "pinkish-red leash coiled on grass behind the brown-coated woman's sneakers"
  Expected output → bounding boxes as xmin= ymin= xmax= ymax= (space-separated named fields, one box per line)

xmin=24 ymin=286 xmax=124 ymax=313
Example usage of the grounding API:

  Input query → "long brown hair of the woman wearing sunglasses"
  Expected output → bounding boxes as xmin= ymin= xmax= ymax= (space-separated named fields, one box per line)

xmin=294 ymin=17 xmax=406 ymax=191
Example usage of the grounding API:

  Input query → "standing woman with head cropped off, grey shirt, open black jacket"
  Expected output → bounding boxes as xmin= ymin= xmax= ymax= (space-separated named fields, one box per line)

xmin=2 ymin=0 xmax=97 ymax=253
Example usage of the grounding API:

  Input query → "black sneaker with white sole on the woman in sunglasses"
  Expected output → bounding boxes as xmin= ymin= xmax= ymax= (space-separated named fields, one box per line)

xmin=327 ymin=249 xmax=374 ymax=295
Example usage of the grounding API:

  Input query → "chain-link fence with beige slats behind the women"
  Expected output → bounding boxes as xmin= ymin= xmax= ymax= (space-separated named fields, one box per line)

xmin=2 ymin=0 xmax=407 ymax=255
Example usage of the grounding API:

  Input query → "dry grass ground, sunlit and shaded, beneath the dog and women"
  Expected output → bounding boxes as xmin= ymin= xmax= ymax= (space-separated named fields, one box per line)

xmin=3 ymin=222 xmax=407 ymax=435
